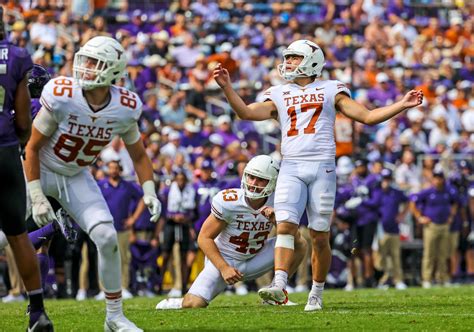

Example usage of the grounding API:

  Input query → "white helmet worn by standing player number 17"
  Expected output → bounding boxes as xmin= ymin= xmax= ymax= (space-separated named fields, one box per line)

xmin=278 ymin=39 xmax=326 ymax=81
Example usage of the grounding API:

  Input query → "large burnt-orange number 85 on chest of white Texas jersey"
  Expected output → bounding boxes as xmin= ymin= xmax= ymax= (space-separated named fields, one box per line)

xmin=54 ymin=134 xmax=109 ymax=166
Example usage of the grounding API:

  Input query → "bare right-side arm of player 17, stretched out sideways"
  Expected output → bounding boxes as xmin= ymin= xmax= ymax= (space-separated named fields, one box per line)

xmin=335 ymin=90 xmax=423 ymax=125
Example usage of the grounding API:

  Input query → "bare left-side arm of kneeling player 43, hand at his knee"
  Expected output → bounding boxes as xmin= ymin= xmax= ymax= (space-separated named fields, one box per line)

xmin=198 ymin=214 xmax=244 ymax=285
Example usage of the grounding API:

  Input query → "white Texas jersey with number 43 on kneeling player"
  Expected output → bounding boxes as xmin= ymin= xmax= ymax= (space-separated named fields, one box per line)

xmin=211 ymin=188 xmax=273 ymax=260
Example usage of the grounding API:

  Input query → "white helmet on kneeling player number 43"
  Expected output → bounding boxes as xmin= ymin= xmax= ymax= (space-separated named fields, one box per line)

xmin=242 ymin=155 xmax=280 ymax=199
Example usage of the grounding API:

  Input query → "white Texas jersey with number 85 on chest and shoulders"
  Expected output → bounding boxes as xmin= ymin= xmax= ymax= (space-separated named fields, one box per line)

xmin=35 ymin=77 xmax=142 ymax=176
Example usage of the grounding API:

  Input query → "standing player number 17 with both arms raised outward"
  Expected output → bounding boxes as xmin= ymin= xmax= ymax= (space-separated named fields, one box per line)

xmin=213 ymin=40 xmax=423 ymax=311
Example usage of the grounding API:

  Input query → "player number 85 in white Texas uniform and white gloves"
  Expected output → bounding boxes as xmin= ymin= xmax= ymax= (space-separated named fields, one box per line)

xmin=25 ymin=37 xmax=161 ymax=331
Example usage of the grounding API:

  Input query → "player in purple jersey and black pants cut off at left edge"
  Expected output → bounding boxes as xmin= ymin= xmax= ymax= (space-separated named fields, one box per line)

xmin=0 ymin=14 xmax=53 ymax=331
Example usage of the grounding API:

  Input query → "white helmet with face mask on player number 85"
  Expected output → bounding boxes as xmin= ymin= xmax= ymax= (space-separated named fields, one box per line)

xmin=73 ymin=36 xmax=127 ymax=90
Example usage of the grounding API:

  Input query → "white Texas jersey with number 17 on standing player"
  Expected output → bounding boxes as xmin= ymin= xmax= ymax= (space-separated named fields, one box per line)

xmin=264 ymin=80 xmax=351 ymax=161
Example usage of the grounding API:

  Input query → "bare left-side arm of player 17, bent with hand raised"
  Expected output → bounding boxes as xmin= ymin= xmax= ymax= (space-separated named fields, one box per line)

xmin=213 ymin=63 xmax=277 ymax=121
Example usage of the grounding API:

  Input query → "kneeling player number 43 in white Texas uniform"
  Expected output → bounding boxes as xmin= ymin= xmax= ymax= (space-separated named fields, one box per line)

xmin=156 ymin=155 xmax=306 ymax=309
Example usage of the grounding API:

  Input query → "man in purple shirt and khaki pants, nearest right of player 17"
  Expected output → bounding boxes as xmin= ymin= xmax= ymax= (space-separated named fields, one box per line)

xmin=378 ymin=168 xmax=408 ymax=290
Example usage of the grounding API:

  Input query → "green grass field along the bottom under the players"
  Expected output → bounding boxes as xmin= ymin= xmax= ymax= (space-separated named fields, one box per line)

xmin=0 ymin=286 xmax=474 ymax=332
